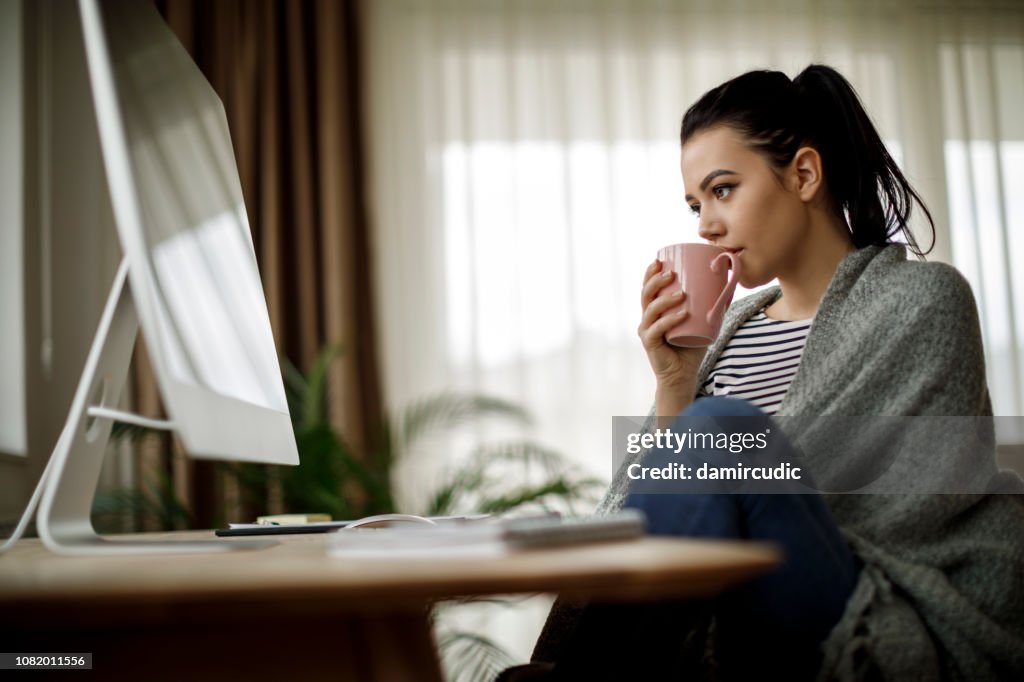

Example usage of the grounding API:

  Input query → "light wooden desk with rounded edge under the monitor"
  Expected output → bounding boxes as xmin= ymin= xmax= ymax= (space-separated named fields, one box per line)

xmin=0 ymin=531 xmax=778 ymax=682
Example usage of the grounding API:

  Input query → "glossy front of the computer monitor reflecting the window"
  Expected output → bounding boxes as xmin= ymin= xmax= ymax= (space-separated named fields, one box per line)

xmin=92 ymin=0 xmax=297 ymax=463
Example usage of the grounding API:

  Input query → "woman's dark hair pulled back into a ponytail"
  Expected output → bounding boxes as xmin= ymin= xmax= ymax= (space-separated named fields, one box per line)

xmin=680 ymin=65 xmax=935 ymax=256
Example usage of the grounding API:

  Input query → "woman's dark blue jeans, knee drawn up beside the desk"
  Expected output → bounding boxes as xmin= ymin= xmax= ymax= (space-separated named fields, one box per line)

xmin=555 ymin=397 xmax=860 ymax=680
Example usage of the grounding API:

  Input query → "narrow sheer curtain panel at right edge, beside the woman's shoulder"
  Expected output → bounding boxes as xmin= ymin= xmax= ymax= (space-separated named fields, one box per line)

xmin=937 ymin=31 xmax=1024 ymax=415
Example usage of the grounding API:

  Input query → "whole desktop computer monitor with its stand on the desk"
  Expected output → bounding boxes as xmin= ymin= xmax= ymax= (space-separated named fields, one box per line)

xmin=17 ymin=0 xmax=298 ymax=553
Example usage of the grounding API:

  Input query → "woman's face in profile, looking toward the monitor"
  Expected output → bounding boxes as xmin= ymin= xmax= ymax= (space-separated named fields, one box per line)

xmin=680 ymin=126 xmax=809 ymax=288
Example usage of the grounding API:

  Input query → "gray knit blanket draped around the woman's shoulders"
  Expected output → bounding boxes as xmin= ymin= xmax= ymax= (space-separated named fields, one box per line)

xmin=534 ymin=246 xmax=1024 ymax=681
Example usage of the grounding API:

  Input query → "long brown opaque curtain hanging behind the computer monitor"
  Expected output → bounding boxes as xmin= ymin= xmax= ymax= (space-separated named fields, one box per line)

xmin=137 ymin=0 xmax=382 ymax=525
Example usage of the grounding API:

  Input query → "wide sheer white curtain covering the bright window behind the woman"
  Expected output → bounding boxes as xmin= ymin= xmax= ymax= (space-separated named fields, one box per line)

xmin=367 ymin=0 xmax=1024 ymax=655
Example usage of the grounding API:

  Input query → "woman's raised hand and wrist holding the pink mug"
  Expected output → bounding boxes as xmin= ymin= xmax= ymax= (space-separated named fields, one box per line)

xmin=637 ymin=260 xmax=707 ymax=417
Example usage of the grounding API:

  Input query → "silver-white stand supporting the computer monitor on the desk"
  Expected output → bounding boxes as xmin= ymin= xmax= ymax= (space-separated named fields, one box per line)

xmin=0 ymin=261 xmax=278 ymax=554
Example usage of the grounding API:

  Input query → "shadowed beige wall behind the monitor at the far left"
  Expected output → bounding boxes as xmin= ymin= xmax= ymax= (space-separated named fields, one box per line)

xmin=0 ymin=0 xmax=120 ymax=522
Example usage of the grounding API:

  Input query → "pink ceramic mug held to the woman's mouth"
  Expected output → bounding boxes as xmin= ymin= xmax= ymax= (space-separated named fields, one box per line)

xmin=657 ymin=244 xmax=739 ymax=348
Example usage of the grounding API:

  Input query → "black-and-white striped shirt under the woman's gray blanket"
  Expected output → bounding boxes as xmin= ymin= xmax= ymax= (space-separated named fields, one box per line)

xmin=698 ymin=310 xmax=812 ymax=415
